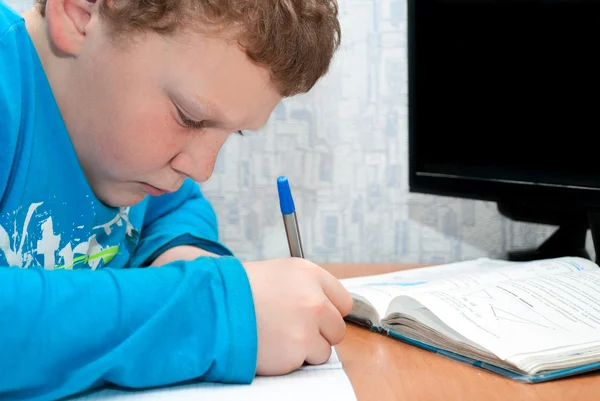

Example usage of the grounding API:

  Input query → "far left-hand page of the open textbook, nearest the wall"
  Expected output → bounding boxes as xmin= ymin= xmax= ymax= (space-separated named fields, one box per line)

xmin=342 ymin=257 xmax=598 ymax=318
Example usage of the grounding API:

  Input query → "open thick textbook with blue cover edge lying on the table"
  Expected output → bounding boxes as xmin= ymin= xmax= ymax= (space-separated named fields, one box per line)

xmin=342 ymin=257 xmax=600 ymax=383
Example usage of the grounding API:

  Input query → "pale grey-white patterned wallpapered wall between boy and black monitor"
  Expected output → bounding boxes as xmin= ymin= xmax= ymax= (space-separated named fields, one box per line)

xmin=203 ymin=0 xmax=568 ymax=262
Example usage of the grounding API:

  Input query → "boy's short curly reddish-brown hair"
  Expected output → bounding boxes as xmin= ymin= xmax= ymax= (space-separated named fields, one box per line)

xmin=36 ymin=0 xmax=341 ymax=97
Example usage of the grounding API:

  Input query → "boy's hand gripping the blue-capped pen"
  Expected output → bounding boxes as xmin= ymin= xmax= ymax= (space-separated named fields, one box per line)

xmin=244 ymin=258 xmax=352 ymax=375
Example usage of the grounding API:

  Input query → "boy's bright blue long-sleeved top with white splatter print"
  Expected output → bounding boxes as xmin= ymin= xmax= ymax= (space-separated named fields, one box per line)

xmin=0 ymin=0 xmax=257 ymax=400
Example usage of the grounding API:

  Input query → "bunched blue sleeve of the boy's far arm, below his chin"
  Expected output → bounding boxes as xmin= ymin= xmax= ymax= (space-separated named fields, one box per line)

xmin=132 ymin=179 xmax=232 ymax=265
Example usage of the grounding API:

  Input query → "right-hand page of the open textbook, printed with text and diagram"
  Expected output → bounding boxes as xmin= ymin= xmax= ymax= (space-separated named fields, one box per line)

xmin=411 ymin=268 xmax=600 ymax=359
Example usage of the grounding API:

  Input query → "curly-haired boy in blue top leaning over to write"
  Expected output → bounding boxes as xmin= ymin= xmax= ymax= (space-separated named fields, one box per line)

xmin=0 ymin=0 xmax=352 ymax=400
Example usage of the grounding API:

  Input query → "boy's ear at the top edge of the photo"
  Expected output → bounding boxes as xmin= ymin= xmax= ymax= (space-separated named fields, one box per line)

xmin=46 ymin=0 xmax=96 ymax=56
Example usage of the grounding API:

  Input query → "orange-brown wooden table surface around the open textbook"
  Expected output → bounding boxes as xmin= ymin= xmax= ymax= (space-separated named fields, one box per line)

xmin=323 ymin=264 xmax=600 ymax=401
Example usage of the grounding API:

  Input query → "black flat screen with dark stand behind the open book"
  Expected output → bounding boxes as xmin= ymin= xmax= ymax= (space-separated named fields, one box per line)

xmin=407 ymin=0 xmax=600 ymax=260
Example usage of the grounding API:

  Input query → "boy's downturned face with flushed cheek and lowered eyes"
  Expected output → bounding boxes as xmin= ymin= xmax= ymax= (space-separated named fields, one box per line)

xmin=48 ymin=11 xmax=281 ymax=206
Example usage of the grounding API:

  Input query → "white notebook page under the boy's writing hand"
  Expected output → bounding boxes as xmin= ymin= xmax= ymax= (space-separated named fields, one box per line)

xmin=69 ymin=348 xmax=356 ymax=401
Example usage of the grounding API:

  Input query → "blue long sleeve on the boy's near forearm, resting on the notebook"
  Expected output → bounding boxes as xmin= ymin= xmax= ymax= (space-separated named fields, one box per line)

xmin=0 ymin=257 xmax=257 ymax=400
